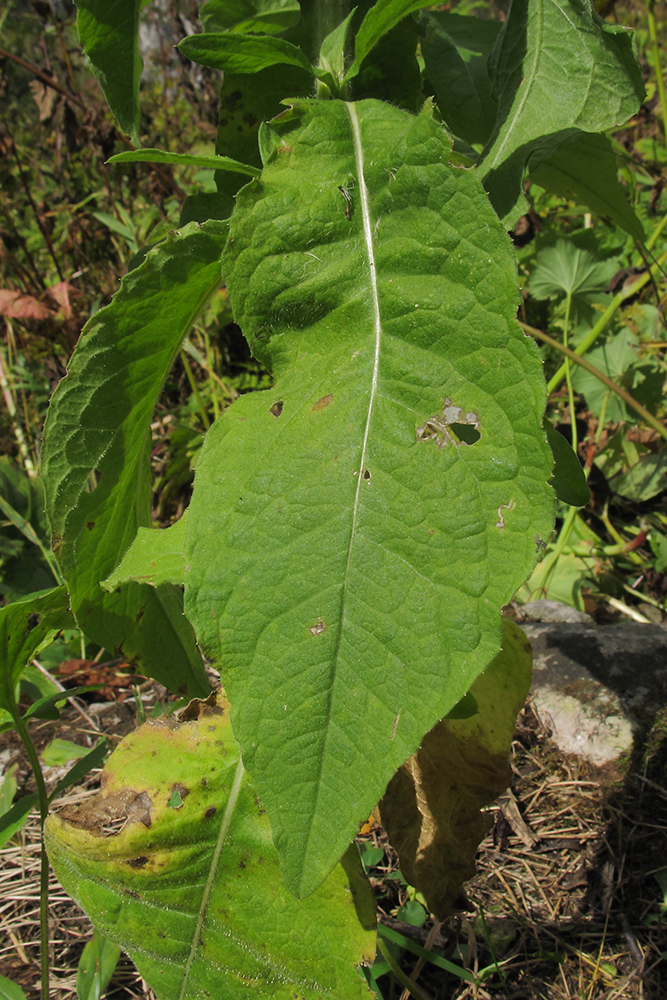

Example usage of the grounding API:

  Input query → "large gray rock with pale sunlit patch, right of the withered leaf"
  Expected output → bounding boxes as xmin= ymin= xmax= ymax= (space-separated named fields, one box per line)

xmin=519 ymin=616 xmax=667 ymax=766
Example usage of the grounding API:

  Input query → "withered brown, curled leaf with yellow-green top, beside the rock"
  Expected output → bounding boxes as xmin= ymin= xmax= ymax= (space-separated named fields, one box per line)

xmin=380 ymin=621 xmax=533 ymax=920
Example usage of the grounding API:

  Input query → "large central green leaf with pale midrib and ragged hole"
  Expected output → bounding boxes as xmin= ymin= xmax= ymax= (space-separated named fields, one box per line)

xmin=186 ymin=101 xmax=553 ymax=895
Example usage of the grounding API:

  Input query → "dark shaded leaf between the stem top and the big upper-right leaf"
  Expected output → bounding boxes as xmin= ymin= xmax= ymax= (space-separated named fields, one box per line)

xmin=421 ymin=11 xmax=501 ymax=145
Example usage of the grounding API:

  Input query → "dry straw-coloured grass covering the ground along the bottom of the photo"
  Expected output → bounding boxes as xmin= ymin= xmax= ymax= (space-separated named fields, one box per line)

xmin=0 ymin=706 xmax=667 ymax=1000
